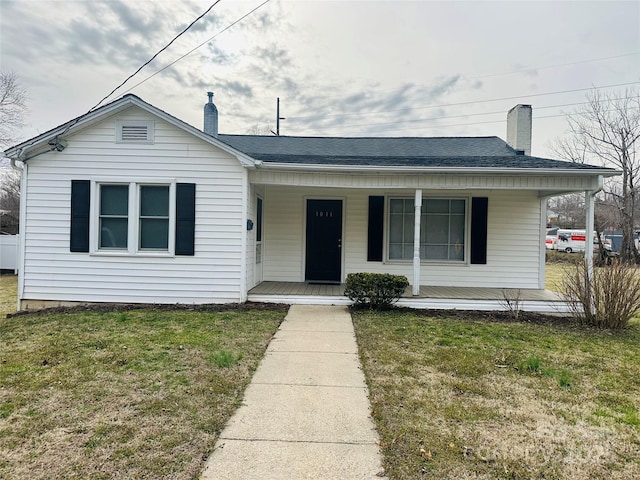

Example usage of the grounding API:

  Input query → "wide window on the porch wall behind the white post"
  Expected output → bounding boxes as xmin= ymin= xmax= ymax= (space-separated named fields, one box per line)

xmin=388 ymin=198 xmax=467 ymax=262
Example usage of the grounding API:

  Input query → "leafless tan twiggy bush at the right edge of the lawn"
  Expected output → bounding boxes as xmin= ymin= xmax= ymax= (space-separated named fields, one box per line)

xmin=561 ymin=260 xmax=640 ymax=329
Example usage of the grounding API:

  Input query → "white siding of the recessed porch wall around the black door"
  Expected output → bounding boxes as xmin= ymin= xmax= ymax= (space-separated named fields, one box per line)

xmin=263 ymin=186 xmax=541 ymax=288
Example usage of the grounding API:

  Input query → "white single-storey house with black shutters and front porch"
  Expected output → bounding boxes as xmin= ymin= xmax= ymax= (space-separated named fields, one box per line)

xmin=5 ymin=95 xmax=617 ymax=309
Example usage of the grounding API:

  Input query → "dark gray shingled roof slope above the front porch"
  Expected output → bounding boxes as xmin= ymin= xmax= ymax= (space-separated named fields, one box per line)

xmin=218 ymin=134 xmax=601 ymax=170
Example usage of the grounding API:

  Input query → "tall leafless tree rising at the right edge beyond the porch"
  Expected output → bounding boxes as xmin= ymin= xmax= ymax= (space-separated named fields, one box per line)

xmin=554 ymin=89 xmax=640 ymax=263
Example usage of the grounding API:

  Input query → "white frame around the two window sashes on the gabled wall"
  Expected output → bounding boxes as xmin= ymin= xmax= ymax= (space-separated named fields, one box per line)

xmin=89 ymin=179 xmax=176 ymax=257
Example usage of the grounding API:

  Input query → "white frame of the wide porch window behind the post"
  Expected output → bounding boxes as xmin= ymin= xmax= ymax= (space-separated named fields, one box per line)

xmin=383 ymin=195 xmax=471 ymax=266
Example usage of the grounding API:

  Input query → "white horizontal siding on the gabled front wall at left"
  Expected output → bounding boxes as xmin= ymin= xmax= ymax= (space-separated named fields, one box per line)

xmin=23 ymin=107 xmax=246 ymax=303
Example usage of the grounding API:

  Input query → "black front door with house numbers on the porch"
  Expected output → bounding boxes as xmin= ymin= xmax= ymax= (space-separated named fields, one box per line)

xmin=305 ymin=200 xmax=342 ymax=282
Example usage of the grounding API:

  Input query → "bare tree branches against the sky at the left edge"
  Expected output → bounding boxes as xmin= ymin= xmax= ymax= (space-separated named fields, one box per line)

xmin=0 ymin=72 xmax=27 ymax=149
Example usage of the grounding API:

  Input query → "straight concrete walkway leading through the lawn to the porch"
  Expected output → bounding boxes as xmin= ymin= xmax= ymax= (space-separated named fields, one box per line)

xmin=201 ymin=305 xmax=382 ymax=480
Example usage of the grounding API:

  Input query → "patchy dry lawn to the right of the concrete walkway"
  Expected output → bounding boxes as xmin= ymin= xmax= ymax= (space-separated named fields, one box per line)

xmin=353 ymin=312 xmax=640 ymax=480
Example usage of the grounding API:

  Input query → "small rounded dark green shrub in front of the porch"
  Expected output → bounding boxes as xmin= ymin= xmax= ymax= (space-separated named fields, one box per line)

xmin=344 ymin=273 xmax=409 ymax=309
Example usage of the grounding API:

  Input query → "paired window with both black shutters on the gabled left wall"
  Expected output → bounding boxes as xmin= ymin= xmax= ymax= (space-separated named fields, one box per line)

xmin=69 ymin=179 xmax=196 ymax=256
